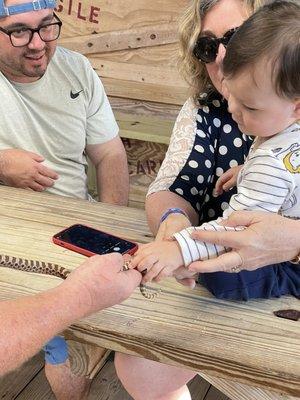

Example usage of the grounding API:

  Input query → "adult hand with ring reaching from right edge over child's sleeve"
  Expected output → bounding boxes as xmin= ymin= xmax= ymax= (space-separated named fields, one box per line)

xmin=188 ymin=211 xmax=300 ymax=273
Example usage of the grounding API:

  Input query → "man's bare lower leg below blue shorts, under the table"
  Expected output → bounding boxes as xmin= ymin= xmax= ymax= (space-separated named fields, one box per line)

xmin=45 ymin=360 xmax=91 ymax=400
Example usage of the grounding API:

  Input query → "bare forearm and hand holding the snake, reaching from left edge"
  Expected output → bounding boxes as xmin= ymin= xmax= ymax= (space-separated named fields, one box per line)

xmin=0 ymin=254 xmax=141 ymax=375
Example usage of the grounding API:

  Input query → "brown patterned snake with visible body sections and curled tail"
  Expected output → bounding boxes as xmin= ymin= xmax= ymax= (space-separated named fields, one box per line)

xmin=0 ymin=254 xmax=159 ymax=300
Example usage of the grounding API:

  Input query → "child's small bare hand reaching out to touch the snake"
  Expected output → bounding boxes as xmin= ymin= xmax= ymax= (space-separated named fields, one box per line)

xmin=131 ymin=240 xmax=184 ymax=283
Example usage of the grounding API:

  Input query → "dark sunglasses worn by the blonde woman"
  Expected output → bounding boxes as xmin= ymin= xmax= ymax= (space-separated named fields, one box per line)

xmin=193 ymin=28 xmax=239 ymax=63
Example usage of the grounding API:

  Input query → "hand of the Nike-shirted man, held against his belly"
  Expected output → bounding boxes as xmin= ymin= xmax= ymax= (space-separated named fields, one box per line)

xmin=0 ymin=149 xmax=58 ymax=192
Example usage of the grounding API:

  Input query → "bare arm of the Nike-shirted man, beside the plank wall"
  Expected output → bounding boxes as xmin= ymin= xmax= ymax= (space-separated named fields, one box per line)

xmin=86 ymin=136 xmax=129 ymax=206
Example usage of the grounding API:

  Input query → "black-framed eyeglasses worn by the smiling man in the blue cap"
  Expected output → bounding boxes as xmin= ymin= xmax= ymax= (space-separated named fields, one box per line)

xmin=0 ymin=13 xmax=62 ymax=47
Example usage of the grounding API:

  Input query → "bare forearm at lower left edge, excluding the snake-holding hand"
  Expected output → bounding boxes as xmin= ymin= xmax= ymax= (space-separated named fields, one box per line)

xmin=0 ymin=287 xmax=77 ymax=375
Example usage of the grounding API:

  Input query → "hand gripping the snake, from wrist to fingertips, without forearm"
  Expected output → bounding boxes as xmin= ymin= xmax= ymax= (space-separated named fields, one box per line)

xmin=60 ymin=253 xmax=142 ymax=318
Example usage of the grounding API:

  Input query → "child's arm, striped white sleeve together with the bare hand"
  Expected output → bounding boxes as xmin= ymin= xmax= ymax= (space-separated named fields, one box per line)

xmin=133 ymin=151 xmax=294 ymax=282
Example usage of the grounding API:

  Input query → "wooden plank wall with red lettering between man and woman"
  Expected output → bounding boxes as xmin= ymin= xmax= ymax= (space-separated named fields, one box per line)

xmin=56 ymin=0 xmax=188 ymax=207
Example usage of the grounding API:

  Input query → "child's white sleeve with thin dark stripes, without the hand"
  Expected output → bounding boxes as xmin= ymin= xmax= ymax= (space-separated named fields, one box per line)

xmin=174 ymin=150 xmax=295 ymax=267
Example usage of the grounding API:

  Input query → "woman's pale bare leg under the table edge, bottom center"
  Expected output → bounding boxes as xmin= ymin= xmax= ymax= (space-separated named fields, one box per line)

xmin=115 ymin=353 xmax=196 ymax=400
